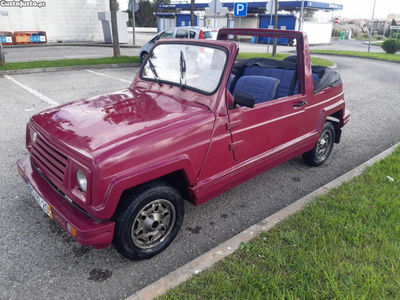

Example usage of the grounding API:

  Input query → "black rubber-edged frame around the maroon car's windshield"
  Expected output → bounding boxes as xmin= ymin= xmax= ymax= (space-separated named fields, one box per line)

xmin=139 ymin=39 xmax=229 ymax=96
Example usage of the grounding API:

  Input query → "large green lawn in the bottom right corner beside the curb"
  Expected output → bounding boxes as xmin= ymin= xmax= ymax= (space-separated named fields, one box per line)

xmin=161 ymin=148 xmax=400 ymax=300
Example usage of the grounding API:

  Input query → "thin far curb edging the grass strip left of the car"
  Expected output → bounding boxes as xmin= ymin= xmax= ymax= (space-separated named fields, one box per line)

xmin=0 ymin=63 xmax=141 ymax=76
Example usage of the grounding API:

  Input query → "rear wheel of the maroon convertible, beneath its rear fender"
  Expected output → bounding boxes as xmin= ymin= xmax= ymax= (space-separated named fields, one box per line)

xmin=303 ymin=122 xmax=336 ymax=167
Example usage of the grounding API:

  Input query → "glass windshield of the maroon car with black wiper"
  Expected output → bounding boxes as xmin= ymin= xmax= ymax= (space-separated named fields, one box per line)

xmin=142 ymin=43 xmax=226 ymax=94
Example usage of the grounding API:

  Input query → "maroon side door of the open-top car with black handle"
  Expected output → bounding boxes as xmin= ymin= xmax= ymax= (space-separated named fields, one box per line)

xmin=228 ymin=72 xmax=311 ymax=161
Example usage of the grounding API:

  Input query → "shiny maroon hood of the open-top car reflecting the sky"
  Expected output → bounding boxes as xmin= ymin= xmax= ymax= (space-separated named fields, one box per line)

xmin=31 ymin=88 xmax=208 ymax=156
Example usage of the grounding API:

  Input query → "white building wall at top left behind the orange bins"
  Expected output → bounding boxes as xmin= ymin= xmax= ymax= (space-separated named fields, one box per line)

xmin=0 ymin=0 xmax=110 ymax=42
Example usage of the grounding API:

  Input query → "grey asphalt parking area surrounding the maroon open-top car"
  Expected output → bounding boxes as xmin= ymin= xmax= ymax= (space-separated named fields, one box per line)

xmin=0 ymin=57 xmax=400 ymax=299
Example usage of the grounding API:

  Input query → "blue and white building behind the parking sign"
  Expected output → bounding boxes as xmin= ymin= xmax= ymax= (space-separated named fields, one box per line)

xmin=156 ymin=1 xmax=343 ymax=44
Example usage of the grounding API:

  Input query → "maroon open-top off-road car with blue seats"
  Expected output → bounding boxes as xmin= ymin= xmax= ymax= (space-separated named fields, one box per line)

xmin=18 ymin=29 xmax=350 ymax=260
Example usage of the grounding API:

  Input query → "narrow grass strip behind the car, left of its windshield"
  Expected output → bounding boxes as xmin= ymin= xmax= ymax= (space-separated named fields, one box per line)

xmin=0 ymin=56 xmax=140 ymax=71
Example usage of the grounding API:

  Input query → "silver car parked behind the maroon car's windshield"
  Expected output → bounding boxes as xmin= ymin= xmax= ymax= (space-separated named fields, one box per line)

xmin=139 ymin=26 xmax=218 ymax=63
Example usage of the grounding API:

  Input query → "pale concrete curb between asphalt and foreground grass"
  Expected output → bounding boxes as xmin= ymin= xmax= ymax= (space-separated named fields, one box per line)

xmin=126 ymin=143 xmax=400 ymax=300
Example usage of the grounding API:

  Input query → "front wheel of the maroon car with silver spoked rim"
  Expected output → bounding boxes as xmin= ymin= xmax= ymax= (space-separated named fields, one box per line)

xmin=113 ymin=182 xmax=184 ymax=260
